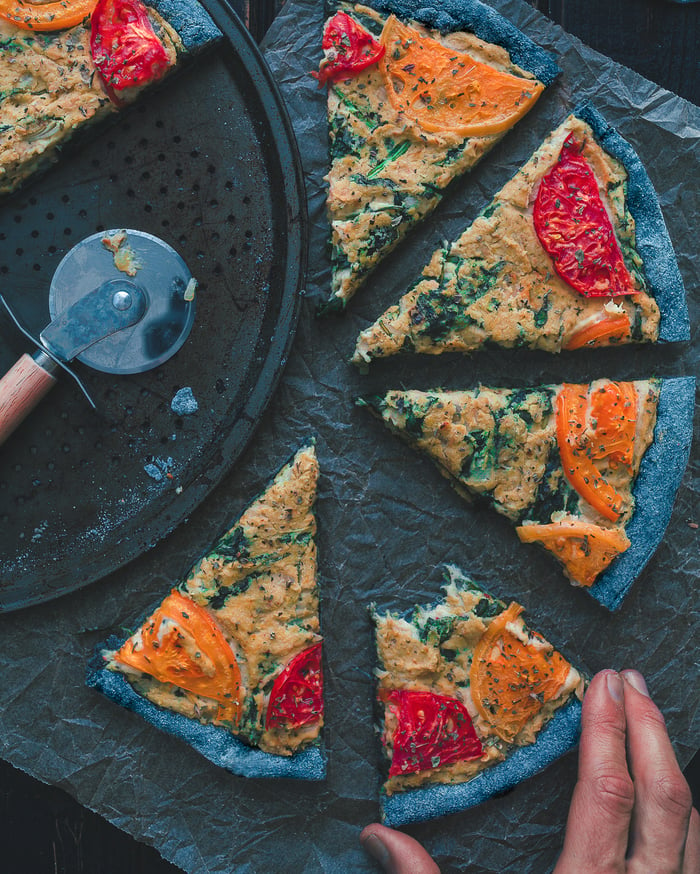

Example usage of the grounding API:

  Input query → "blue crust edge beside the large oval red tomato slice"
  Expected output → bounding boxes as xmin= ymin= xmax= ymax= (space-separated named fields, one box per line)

xmin=574 ymin=103 xmax=690 ymax=343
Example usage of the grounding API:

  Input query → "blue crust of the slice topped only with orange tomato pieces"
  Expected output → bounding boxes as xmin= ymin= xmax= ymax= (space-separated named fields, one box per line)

xmin=589 ymin=376 xmax=695 ymax=610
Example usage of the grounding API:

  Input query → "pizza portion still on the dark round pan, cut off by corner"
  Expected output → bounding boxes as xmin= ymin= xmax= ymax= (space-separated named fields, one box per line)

xmin=0 ymin=0 xmax=221 ymax=195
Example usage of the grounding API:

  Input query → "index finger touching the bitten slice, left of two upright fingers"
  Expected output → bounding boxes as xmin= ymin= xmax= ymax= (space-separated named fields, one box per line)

xmin=555 ymin=671 xmax=634 ymax=874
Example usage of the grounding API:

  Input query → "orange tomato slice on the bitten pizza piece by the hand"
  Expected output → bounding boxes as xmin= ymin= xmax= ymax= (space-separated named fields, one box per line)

xmin=469 ymin=603 xmax=571 ymax=743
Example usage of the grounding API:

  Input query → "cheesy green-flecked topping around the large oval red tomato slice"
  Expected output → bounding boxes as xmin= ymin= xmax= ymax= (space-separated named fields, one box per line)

xmin=353 ymin=116 xmax=660 ymax=367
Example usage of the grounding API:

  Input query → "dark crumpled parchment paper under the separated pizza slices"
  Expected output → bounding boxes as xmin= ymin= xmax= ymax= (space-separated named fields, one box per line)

xmin=0 ymin=0 xmax=700 ymax=874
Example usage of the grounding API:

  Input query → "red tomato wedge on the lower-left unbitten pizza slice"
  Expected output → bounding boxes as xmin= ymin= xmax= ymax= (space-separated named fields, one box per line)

xmin=265 ymin=642 xmax=323 ymax=728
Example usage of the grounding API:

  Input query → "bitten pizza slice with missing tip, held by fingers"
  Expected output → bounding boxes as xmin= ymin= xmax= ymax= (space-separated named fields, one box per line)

xmin=373 ymin=566 xmax=584 ymax=826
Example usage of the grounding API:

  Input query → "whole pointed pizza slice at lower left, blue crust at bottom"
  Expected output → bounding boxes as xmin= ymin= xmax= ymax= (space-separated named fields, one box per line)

xmin=88 ymin=446 xmax=325 ymax=779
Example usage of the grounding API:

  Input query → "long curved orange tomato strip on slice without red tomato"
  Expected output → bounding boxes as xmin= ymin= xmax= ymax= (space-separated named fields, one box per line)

xmin=556 ymin=385 xmax=622 ymax=522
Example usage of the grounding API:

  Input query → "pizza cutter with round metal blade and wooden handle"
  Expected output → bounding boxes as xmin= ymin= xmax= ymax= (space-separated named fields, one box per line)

xmin=0 ymin=230 xmax=196 ymax=444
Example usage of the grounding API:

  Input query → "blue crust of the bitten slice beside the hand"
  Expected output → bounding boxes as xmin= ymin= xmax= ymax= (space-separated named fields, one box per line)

xmin=379 ymin=698 xmax=581 ymax=826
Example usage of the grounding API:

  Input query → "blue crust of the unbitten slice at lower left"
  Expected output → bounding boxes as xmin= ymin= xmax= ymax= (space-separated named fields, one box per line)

xmin=86 ymin=637 xmax=326 ymax=780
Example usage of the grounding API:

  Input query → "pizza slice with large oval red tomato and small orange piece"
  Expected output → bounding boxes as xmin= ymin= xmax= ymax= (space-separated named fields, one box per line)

xmin=352 ymin=105 xmax=690 ymax=369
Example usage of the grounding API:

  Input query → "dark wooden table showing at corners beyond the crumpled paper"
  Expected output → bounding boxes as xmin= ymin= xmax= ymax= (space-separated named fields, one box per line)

xmin=0 ymin=0 xmax=700 ymax=874
